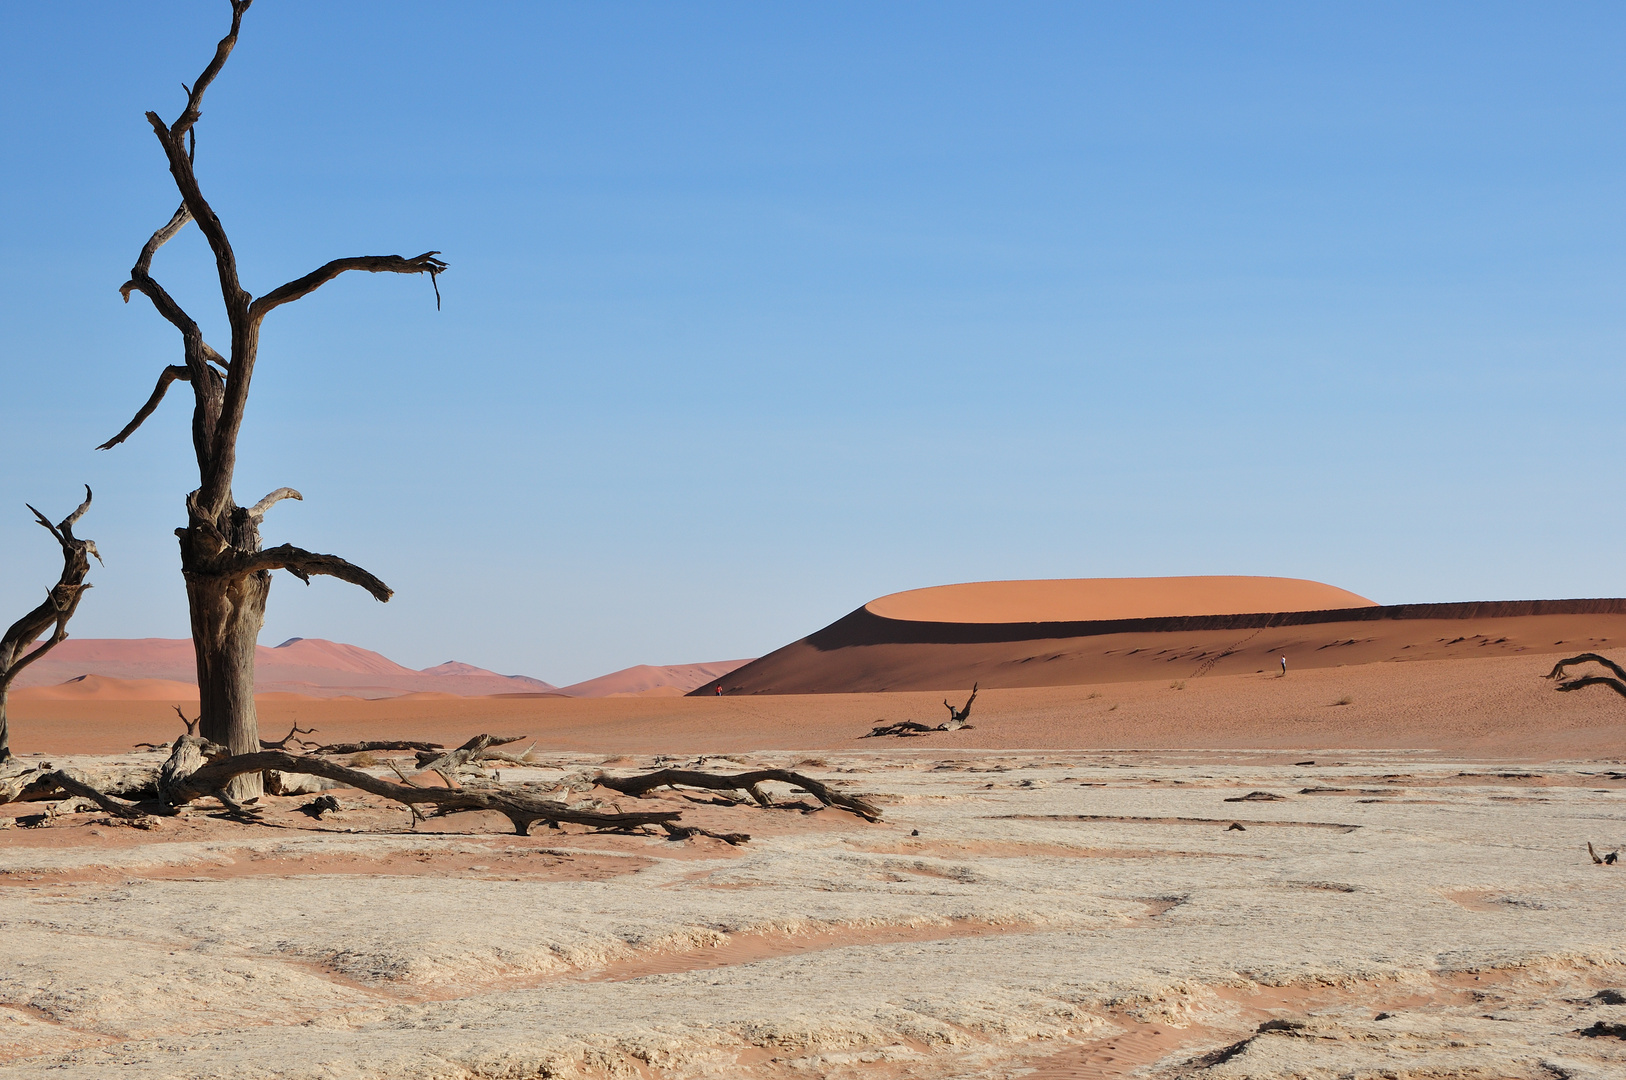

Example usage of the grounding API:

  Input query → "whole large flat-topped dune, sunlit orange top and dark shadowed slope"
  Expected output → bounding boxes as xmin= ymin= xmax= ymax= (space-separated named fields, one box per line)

xmin=694 ymin=577 xmax=1626 ymax=695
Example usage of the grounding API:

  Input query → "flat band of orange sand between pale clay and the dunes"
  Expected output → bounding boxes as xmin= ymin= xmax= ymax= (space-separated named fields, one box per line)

xmin=11 ymin=642 xmax=1626 ymax=763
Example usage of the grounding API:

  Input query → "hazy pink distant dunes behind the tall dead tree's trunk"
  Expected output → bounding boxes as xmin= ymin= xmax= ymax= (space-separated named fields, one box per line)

xmin=16 ymin=638 xmax=553 ymax=699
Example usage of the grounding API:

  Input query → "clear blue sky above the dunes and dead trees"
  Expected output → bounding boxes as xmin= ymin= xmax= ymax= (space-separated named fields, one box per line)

xmin=0 ymin=0 xmax=1626 ymax=683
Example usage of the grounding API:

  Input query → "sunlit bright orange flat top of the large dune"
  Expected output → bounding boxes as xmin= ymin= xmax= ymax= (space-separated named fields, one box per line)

xmin=863 ymin=576 xmax=1377 ymax=623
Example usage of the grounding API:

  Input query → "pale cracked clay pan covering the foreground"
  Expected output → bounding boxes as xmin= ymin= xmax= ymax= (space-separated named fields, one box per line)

xmin=0 ymin=750 xmax=1626 ymax=1080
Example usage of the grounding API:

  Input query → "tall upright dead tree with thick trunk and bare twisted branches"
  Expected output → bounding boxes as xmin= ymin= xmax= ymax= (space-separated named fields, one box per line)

xmin=99 ymin=0 xmax=446 ymax=800
